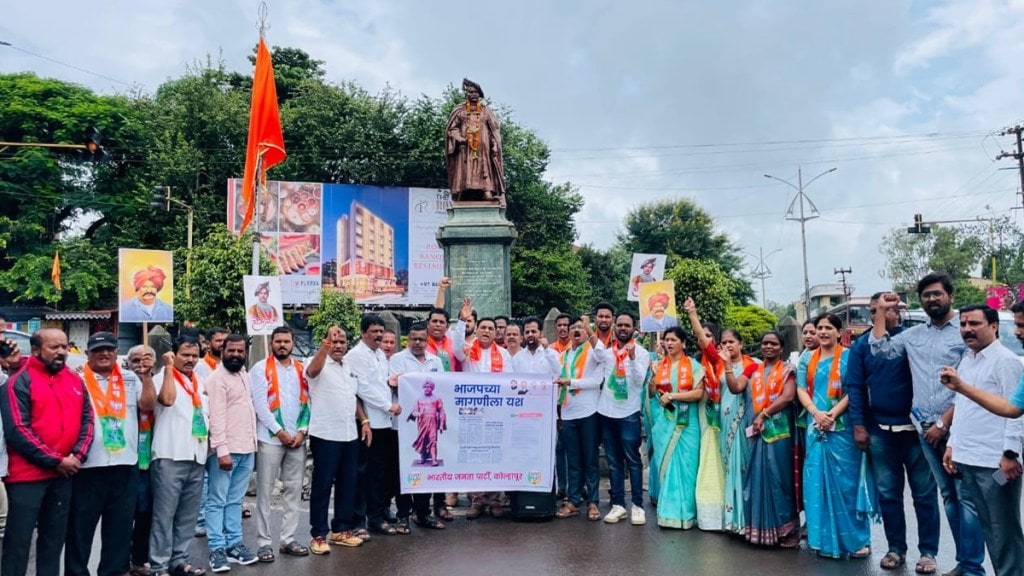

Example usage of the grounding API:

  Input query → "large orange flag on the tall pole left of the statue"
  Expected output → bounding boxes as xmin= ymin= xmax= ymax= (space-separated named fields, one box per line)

xmin=239 ymin=37 xmax=288 ymax=233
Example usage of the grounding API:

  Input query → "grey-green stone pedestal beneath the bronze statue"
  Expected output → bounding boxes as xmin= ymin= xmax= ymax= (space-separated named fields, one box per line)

xmin=437 ymin=201 xmax=516 ymax=321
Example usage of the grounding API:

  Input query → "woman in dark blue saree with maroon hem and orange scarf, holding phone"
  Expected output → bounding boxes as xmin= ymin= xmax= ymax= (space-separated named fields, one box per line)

xmin=726 ymin=332 xmax=800 ymax=548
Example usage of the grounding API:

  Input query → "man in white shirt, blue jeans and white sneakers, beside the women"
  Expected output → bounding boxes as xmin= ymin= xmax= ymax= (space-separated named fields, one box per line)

xmin=597 ymin=313 xmax=650 ymax=526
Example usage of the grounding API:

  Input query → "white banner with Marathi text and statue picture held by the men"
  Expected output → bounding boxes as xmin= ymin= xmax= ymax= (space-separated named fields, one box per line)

xmin=398 ymin=372 xmax=558 ymax=494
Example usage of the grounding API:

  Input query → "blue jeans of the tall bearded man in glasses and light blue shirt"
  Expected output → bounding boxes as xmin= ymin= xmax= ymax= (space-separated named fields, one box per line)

xmin=919 ymin=426 xmax=985 ymax=576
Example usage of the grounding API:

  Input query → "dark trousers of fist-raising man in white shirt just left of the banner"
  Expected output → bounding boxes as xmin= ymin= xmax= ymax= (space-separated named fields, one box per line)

xmin=309 ymin=436 xmax=362 ymax=538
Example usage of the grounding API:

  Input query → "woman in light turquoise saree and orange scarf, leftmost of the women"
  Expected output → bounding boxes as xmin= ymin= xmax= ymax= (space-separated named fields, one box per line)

xmin=648 ymin=326 xmax=703 ymax=529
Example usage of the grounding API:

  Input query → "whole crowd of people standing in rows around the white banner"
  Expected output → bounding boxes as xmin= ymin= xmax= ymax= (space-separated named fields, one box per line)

xmin=0 ymin=274 xmax=1024 ymax=576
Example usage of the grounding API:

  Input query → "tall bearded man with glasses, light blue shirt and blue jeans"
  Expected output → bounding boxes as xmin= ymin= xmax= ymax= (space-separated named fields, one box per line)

xmin=868 ymin=273 xmax=985 ymax=576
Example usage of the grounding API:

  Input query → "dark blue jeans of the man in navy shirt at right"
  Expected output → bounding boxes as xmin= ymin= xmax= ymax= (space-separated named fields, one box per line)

xmin=869 ymin=426 xmax=939 ymax=558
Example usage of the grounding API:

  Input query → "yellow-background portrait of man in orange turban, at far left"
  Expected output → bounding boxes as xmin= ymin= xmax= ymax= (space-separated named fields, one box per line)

xmin=118 ymin=248 xmax=174 ymax=323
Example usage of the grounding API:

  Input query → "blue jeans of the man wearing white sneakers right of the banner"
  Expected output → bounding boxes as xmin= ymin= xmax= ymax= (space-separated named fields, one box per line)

xmin=600 ymin=411 xmax=643 ymax=507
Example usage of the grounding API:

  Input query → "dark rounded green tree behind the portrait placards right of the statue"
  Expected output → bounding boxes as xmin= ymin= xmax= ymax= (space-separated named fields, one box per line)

xmin=617 ymin=198 xmax=754 ymax=303
